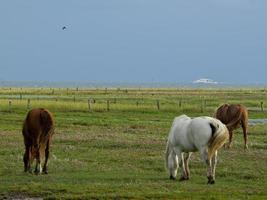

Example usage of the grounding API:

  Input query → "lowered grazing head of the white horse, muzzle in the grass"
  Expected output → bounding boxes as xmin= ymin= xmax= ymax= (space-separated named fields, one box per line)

xmin=165 ymin=140 xmax=178 ymax=179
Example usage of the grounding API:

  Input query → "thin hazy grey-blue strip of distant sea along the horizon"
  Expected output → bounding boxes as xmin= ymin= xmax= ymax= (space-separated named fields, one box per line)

xmin=0 ymin=81 xmax=267 ymax=88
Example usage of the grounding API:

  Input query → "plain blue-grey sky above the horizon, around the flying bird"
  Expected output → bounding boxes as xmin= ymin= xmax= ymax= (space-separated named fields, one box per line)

xmin=0 ymin=0 xmax=267 ymax=84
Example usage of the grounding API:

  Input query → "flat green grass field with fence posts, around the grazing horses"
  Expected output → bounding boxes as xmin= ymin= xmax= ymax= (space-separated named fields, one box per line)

xmin=0 ymin=88 xmax=267 ymax=200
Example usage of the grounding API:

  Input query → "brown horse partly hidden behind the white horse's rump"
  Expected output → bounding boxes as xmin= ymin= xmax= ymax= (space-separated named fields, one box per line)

xmin=215 ymin=104 xmax=248 ymax=149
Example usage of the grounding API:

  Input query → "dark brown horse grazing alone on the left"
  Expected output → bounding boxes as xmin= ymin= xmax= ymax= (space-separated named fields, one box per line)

xmin=22 ymin=108 xmax=54 ymax=174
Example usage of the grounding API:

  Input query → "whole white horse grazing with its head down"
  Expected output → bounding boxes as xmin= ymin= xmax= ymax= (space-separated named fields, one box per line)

xmin=165 ymin=115 xmax=229 ymax=184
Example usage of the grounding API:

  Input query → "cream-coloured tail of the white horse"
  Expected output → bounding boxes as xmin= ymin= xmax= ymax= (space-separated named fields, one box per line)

xmin=208 ymin=121 xmax=229 ymax=159
